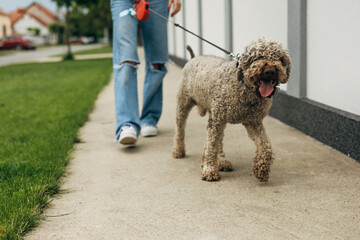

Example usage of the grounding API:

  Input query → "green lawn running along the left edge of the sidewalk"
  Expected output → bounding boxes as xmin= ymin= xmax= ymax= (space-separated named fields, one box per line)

xmin=0 ymin=59 xmax=112 ymax=239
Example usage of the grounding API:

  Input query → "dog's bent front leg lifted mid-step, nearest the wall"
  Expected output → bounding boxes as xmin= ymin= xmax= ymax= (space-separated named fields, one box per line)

xmin=244 ymin=122 xmax=274 ymax=182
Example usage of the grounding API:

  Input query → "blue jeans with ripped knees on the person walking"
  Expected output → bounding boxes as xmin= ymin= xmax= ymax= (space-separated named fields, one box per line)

xmin=111 ymin=0 xmax=169 ymax=140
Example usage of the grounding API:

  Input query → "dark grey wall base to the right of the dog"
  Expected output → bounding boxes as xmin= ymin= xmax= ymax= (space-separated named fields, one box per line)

xmin=269 ymin=91 xmax=360 ymax=162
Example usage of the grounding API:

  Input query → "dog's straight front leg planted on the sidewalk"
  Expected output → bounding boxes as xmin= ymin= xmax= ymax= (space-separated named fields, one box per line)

xmin=201 ymin=114 xmax=225 ymax=181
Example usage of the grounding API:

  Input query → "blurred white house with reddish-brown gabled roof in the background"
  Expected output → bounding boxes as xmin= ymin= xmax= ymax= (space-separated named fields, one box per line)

xmin=10 ymin=2 xmax=58 ymax=45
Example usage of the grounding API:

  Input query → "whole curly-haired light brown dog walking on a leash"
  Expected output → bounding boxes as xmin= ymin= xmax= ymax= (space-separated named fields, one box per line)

xmin=173 ymin=38 xmax=291 ymax=182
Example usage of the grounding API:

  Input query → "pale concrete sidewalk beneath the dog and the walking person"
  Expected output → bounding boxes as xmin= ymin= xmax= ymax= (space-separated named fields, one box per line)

xmin=26 ymin=49 xmax=360 ymax=240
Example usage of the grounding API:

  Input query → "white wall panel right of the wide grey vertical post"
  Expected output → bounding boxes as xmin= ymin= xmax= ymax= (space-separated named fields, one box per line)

xmin=307 ymin=0 xmax=360 ymax=115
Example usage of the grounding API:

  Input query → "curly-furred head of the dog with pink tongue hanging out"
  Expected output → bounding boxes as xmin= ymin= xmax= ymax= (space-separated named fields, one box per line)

xmin=239 ymin=38 xmax=291 ymax=98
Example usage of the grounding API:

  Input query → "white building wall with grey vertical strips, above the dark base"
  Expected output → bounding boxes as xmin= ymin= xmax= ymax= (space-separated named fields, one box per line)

xmin=169 ymin=0 xmax=360 ymax=115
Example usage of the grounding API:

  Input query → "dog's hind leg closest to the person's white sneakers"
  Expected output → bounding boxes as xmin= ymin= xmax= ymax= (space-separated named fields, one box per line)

xmin=173 ymin=90 xmax=195 ymax=158
